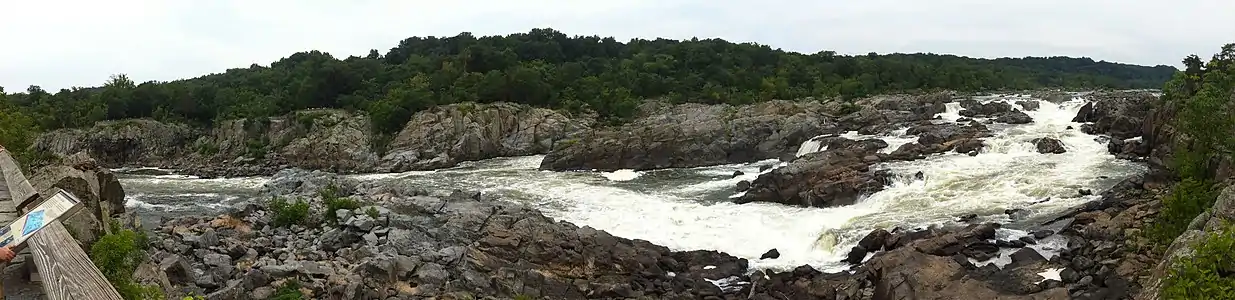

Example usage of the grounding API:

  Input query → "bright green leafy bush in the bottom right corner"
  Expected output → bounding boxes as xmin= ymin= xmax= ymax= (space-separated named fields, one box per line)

xmin=1161 ymin=226 xmax=1235 ymax=299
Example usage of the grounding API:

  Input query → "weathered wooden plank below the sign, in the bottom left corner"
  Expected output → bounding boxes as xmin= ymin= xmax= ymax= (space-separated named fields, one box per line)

xmin=26 ymin=221 xmax=121 ymax=300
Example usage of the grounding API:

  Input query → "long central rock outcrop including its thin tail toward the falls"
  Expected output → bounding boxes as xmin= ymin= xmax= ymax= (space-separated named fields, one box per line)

xmin=541 ymin=93 xmax=952 ymax=170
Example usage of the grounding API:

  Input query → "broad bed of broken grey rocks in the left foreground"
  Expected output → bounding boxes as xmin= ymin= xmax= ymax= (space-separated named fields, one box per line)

xmin=147 ymin=172 xmax=747 ymax=299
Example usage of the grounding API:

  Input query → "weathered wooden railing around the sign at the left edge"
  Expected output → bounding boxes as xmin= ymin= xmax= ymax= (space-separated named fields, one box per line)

xmin=0 ymin=146 xmax=121 ymax=300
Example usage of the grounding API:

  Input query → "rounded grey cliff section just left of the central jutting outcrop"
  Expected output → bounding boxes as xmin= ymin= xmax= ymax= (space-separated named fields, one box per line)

xmin=383 ymin=102 xmax=593 ymax=172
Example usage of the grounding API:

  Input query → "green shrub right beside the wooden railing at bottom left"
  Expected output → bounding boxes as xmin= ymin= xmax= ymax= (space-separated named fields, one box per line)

xmin=90 ymin=221 xmax=165 ymax=300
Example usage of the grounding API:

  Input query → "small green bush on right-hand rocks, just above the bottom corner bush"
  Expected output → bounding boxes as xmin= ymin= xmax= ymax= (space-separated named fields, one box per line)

xmin=1149 ymin=178 xmax=1218 ymax=246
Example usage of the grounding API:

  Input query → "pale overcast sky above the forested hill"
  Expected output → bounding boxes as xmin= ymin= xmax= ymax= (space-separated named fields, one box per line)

xmin=0 ymin=0 xmax=1235 ymax=93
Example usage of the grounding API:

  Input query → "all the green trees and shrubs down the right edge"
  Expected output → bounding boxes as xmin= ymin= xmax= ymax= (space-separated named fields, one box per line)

xmin=1150 ymin=43 xmax=1235 ymax=299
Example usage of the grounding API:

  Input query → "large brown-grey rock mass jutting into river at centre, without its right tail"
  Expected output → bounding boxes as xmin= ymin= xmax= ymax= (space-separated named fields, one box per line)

xmin=541 ymin=101 xmax=840 ymax=170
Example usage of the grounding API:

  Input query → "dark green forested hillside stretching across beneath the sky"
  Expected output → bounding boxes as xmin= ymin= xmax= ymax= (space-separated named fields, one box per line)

xmin=7 ymin=28 xmax=1176 ymax=133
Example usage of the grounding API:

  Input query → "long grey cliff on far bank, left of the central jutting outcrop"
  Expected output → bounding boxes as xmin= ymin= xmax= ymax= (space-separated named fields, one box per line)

xmin=35 ymin=102 xmax=593 ymax=177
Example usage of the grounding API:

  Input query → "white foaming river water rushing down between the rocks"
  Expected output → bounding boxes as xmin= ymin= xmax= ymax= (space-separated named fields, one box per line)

xmin=122 ymin=96 xmax=1144 ymax=270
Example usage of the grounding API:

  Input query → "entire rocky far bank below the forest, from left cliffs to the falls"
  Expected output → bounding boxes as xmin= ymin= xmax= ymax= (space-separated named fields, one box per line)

xmin=35 ymin=93 xmax=1076 ymax=177
